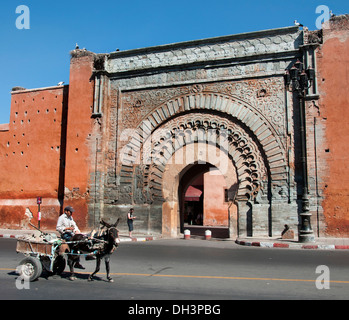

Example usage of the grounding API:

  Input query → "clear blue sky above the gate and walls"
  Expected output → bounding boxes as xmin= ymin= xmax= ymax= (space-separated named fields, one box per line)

xmin=0 ymin=0 xmax=349 ymax=123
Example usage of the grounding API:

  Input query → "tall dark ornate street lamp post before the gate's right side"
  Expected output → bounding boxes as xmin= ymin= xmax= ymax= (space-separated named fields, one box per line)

xmin=285 ymin=60 xmax=315 ymax=242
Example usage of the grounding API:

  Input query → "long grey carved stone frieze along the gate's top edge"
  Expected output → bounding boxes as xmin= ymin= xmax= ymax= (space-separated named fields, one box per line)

xmin=105 ymin=27 xmax=302 ymax=73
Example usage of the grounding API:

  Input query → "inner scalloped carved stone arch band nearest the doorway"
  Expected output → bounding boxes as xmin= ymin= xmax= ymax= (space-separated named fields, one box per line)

xmin=142 ymin=113 xmax=268 ymax=200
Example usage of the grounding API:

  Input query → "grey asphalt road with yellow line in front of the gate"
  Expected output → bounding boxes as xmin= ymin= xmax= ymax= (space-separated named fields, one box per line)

xmin=0 ymin=239 xmax=349 ymax=302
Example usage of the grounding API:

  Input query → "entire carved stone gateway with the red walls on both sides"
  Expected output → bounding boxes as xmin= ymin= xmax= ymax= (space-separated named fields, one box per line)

xmin=0 ymin=16 xmax=349 ymax=237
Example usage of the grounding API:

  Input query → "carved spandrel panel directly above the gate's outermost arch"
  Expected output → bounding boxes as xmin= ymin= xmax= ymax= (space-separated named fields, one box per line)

xmin=122 ymin=77 xmax=286 ymax=141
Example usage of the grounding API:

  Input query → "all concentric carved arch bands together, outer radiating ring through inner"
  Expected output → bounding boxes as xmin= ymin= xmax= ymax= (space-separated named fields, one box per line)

xmin=120 ymin=93 xmax=287 ymax=203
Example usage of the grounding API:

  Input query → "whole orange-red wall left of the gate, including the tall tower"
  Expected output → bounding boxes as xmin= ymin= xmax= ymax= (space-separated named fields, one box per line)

xmin=0 ymin=52 xmax=94 ymax=230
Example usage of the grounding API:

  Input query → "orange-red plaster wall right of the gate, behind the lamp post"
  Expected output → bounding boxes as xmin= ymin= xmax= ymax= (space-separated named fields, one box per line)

xmin=318 ymin=16 xmax=349 ymax=237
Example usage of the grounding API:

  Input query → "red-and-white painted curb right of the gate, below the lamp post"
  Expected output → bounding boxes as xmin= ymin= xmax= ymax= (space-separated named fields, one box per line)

xmin=235 ymin=239 xmax=349 ymax=250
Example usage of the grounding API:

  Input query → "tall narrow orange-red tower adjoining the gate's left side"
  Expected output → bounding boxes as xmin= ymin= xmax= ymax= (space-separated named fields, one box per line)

xmin=64 ymin=54 xmax=94 ymax=230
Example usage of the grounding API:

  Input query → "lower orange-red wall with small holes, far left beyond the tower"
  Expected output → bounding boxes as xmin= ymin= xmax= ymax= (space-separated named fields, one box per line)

xmin=0 ymin=87 xmax=68 ymax=228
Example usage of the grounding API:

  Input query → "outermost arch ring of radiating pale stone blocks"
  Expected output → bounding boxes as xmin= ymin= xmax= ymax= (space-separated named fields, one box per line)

xmin=121 ymin=92 xmax=288 ymax=194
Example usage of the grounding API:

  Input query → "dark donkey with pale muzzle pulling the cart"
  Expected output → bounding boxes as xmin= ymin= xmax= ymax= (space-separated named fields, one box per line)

xmin=68 ymin=218 xmax=120 ymax=282
